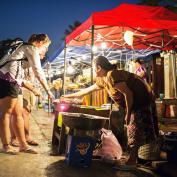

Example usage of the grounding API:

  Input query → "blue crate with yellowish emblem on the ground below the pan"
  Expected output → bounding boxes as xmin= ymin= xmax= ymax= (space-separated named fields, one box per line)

xmin=65 ymin=135 xmax=95 ymax=167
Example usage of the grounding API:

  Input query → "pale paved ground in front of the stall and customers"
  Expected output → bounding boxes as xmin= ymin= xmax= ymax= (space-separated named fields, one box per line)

xmin=0 ymin=110 xmax=162 ymax=177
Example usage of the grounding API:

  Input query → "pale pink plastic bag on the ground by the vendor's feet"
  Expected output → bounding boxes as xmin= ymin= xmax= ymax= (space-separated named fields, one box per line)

xmin=94 ymin=128 xmax=122 ymax=162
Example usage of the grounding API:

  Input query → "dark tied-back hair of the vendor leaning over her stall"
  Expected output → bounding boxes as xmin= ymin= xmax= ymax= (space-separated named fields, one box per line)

xmin=94 ymin=56 xmax=117 ymax=71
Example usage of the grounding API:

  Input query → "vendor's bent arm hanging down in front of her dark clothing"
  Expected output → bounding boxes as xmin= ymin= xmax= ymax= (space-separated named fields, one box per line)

xmin=115 ymin=82 xmax=133 ymax=125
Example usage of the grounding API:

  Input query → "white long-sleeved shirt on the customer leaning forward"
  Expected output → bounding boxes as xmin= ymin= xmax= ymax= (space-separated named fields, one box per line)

xmin=0 ymin=45 xmax=47 ymax=85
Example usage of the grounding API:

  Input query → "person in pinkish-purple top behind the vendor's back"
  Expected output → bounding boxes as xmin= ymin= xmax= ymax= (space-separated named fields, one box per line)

xmin=135 ymin=59 xmax=147 ymax=81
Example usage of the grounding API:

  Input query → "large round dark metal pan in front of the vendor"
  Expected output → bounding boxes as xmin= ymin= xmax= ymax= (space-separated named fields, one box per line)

xmin=61 ymin=112 xmax=109 ymax=130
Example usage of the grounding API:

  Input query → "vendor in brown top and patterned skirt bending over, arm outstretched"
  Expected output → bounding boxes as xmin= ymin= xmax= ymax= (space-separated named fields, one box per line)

xmin=64 ymin=56 xmax=158 ymax=168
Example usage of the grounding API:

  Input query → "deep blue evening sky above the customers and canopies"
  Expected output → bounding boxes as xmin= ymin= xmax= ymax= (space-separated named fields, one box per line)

xmin=0 ymin=0 xmax=139 ymax=54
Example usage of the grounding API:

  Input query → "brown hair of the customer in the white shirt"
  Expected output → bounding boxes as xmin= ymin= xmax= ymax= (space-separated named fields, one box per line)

xmin=28 ymin=34 xmax=51 ymax=44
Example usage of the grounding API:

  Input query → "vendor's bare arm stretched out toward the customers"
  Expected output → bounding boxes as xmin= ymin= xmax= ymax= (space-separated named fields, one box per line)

xmin=63 ymin=84 xmax=101 ymax=98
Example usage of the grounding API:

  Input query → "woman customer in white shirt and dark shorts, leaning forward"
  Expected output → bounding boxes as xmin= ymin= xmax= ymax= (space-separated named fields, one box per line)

xmin=0 ymin=34 xmax=53 ymax=154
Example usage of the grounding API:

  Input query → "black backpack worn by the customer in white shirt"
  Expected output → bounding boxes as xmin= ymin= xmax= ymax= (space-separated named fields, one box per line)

xmin=0 ymin=38 xmax=24 ymax=68
